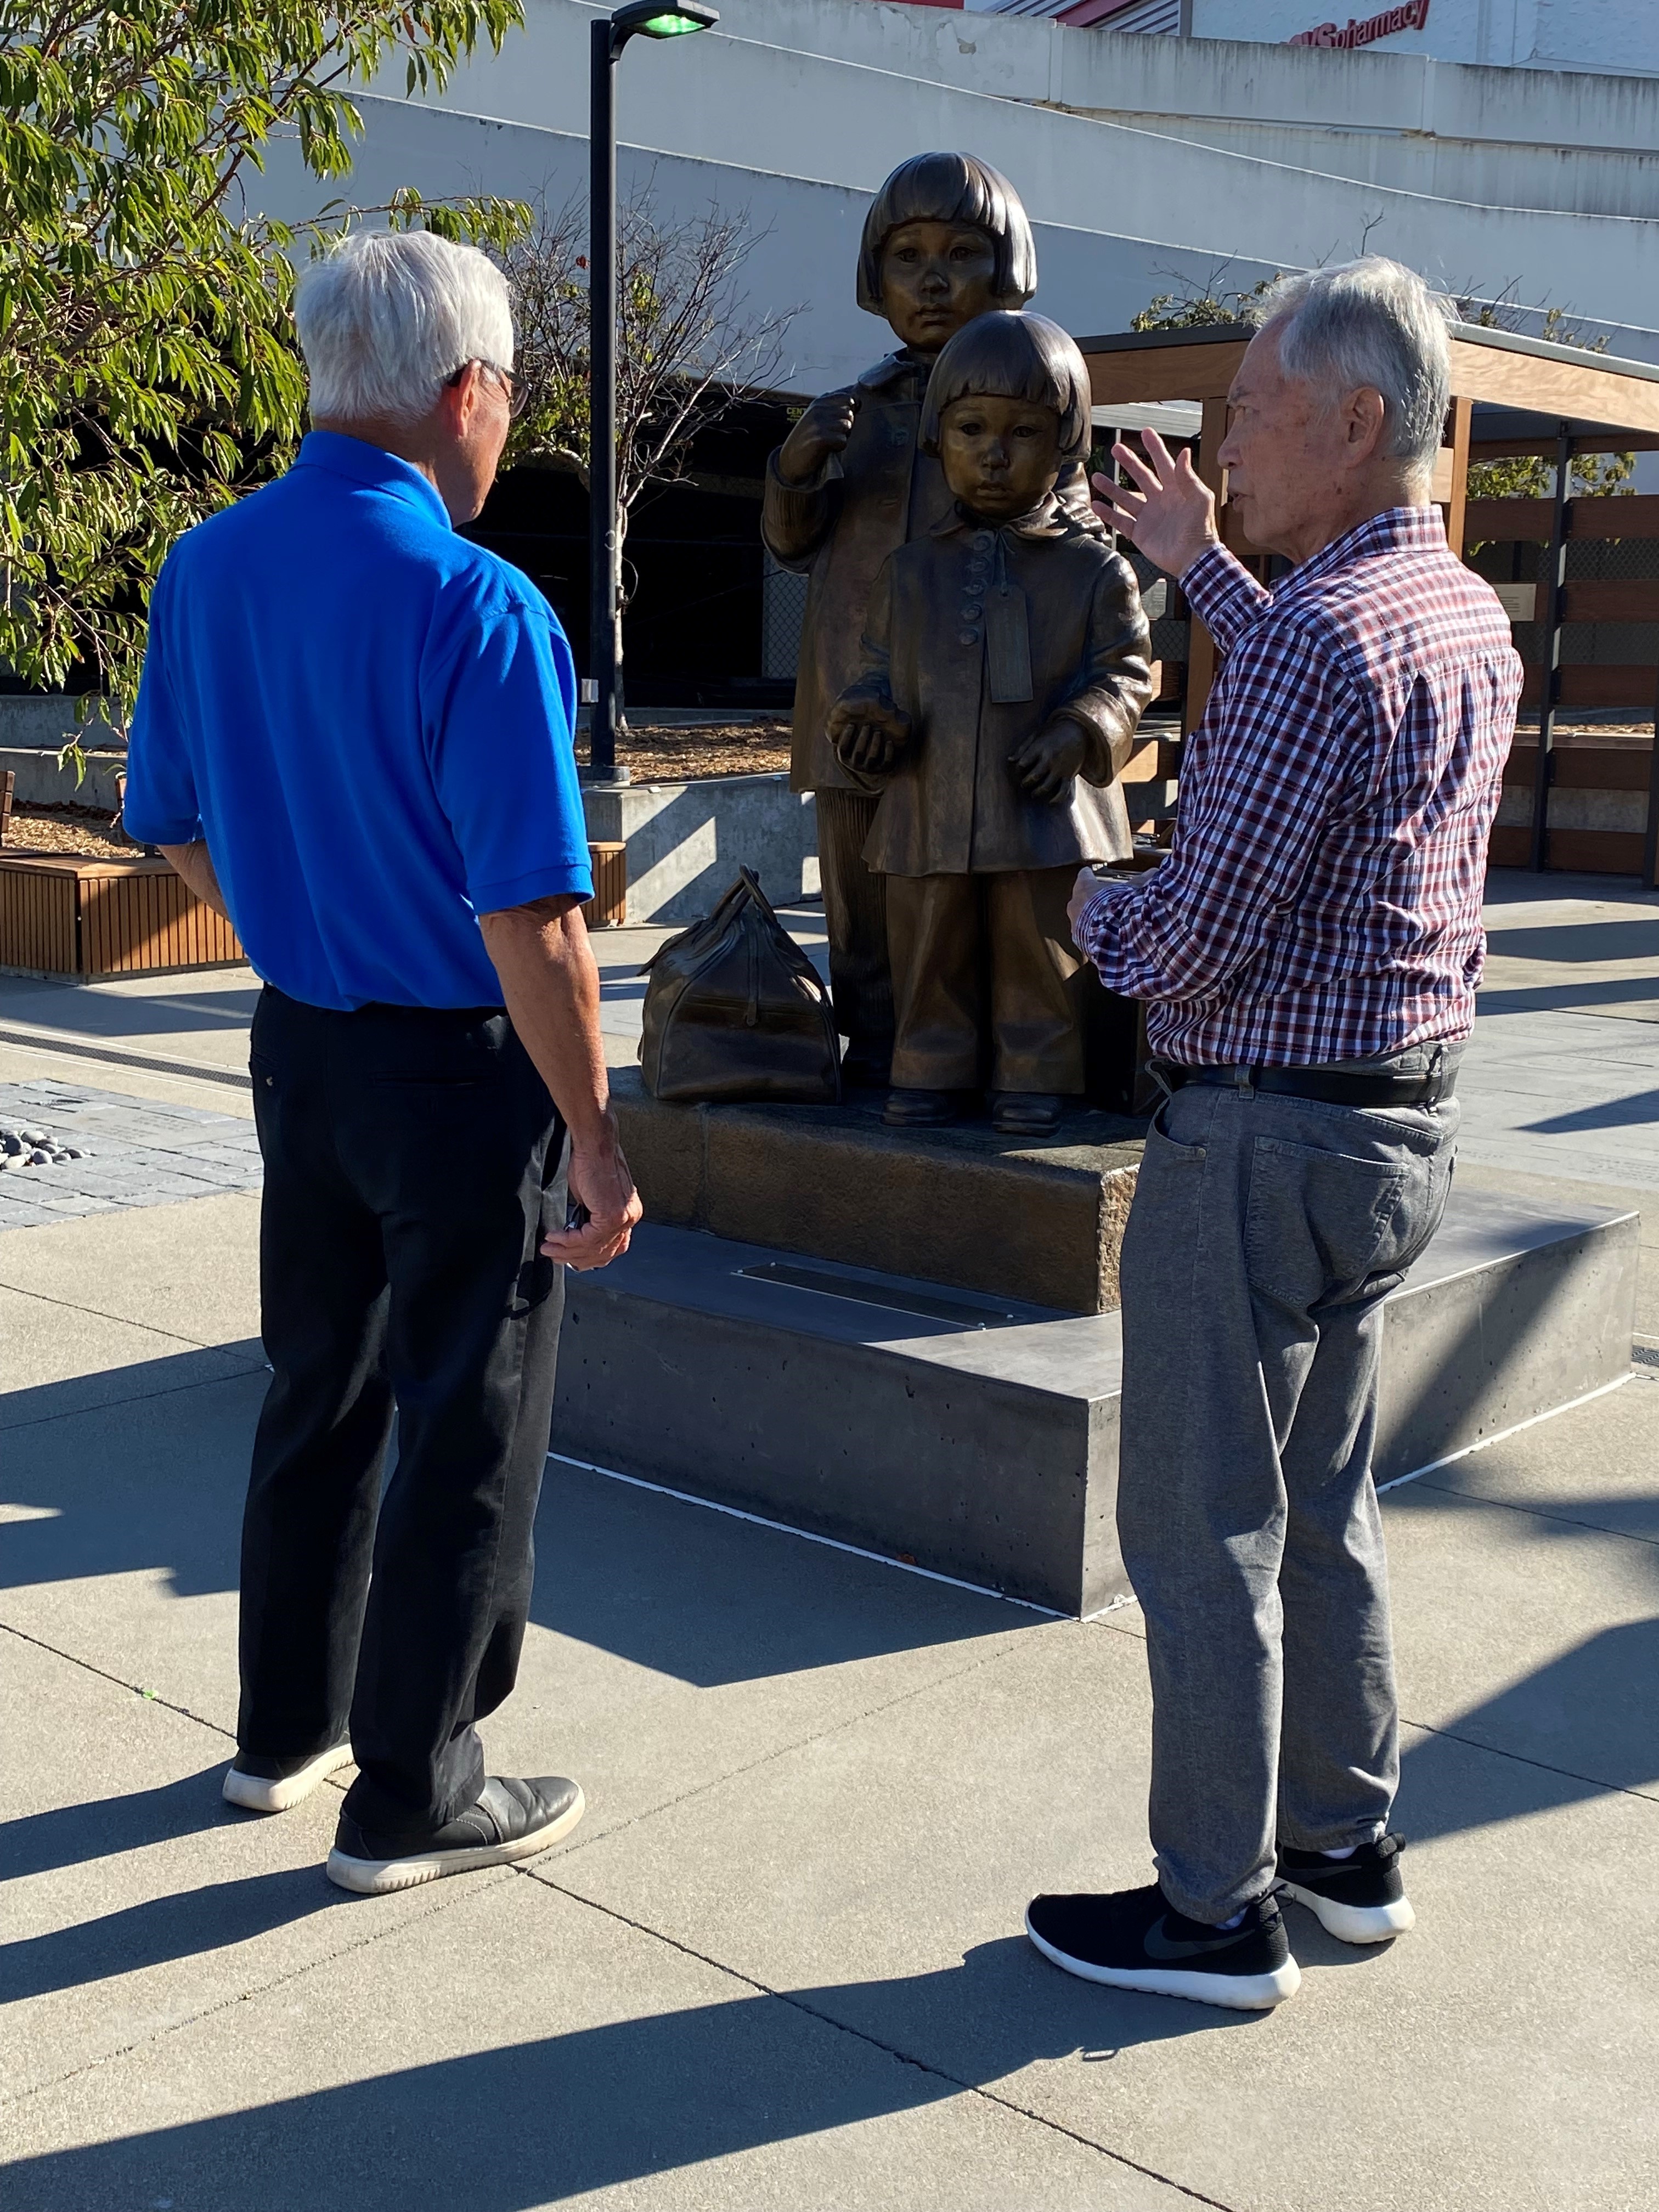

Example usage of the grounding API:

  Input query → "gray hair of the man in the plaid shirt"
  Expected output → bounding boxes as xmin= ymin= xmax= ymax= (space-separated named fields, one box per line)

xmin=1256 ymin=255 xmax=1455 ymax=476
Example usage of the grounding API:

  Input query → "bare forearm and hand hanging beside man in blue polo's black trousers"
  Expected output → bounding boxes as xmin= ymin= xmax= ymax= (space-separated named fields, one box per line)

xmin=478 ymin=896 xmax=644 ymax=1267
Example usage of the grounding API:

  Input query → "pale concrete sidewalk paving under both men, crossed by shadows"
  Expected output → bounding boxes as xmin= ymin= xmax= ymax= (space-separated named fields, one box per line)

xmin=0 ymin=885 xmax=1659 ymax=2212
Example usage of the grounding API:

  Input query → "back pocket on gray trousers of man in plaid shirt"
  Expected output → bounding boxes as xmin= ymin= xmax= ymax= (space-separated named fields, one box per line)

xmin=1245 ymin=1137 xmax=1427 ymax=1312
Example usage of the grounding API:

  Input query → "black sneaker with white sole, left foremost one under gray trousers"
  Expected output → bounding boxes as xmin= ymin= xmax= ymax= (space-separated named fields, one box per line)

xmin=1026 ymin=1882 xmax=1301 ymax=2013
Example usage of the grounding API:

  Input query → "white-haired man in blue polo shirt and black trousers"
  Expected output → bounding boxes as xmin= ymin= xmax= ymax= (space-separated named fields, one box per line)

xmin=126 ymin=232 xmax=639 ymax=1893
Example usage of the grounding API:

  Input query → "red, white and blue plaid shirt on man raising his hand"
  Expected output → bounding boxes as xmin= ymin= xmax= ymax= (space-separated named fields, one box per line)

xmin=1077 ymin=506 xmax=1522 ymax=1066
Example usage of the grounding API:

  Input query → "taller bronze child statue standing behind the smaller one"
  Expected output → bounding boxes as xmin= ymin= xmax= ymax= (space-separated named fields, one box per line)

xmin=761 ymin=153 xmax=1099 ymax=1084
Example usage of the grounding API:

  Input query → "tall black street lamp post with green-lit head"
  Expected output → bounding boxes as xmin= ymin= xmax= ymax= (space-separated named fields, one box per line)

xmin=582 ymin=0 xmax=719 ymax=783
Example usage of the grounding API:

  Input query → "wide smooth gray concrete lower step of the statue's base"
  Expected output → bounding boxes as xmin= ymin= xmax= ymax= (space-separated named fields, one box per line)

xmin=553 ymin=1192 xmax=1639 ymax=1615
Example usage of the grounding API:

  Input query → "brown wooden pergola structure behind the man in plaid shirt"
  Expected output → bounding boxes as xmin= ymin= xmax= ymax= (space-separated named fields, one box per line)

xmin=1077 ymin=323 xmax=1659 ymax=889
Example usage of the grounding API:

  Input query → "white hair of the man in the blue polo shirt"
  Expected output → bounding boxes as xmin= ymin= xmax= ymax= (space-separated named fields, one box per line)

xmin=294 ymin=230 xmax=513 ymax=425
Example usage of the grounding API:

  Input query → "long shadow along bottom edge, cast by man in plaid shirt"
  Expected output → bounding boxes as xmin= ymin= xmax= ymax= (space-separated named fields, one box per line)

xmin=7 ymin=1938 xmax=1261 ymax=2212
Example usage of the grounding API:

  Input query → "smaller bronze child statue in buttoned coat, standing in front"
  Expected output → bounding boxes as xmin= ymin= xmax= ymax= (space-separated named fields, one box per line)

xmin=830 ymin=314 xmax=1150 ymax=1137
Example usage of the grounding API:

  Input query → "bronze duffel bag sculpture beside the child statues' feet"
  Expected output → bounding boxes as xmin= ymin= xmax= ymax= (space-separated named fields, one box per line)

xmin=639 ymin=867 xmax=840 ymax=1106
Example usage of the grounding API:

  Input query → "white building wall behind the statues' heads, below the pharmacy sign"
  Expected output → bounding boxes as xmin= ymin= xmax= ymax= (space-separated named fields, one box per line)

xmin=250 ymin=0 xmax=1659 ymax=392
